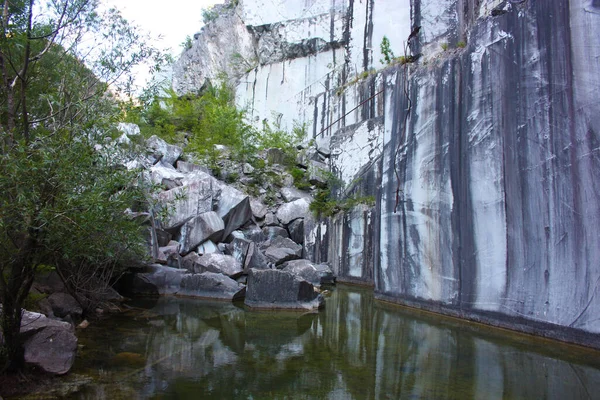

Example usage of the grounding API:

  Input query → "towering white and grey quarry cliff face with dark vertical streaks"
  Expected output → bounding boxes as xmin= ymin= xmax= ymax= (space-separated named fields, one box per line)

xmin=175 ymin=0 xmax=600 ymax=347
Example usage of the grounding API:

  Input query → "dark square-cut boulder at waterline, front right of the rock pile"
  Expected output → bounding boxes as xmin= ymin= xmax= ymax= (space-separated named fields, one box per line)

xmin=244 ymin=269 xmax=324 ymax=310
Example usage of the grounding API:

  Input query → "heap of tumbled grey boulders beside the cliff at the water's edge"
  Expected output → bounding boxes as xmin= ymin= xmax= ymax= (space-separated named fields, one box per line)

xmin=122 ymin=125 xmax=334 ymax=309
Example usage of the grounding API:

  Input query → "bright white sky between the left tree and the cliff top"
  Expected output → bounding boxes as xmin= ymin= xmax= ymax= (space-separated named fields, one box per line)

xmin=101 ymin=0 xmax=223 ymax=84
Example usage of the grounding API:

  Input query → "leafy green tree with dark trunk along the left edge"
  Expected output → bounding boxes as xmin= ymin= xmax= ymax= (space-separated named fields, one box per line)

xmin=0 ymin=0 xmax=160 ymax=370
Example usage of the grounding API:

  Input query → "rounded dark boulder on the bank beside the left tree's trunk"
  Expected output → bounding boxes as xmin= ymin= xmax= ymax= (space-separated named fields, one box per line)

xmin=21 ymin=311 xmax=77 ymax=375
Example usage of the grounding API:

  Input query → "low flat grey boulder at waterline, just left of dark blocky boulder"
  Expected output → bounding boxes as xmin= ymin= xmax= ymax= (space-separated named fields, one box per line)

xmin=179 ymin=271 xmax=246 ymax=301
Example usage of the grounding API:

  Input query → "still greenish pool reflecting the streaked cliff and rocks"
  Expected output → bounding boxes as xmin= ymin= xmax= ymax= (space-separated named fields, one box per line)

xmin=73 ymin=287 xmax=600 ymax=399
